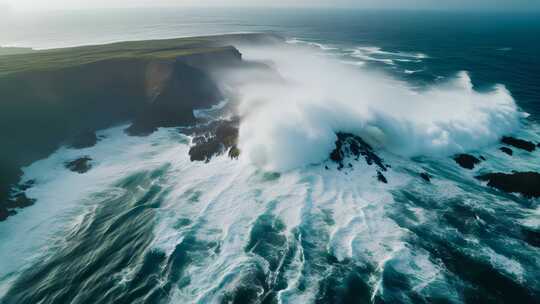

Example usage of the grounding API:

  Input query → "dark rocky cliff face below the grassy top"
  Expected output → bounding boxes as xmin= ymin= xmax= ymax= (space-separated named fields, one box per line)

xmin=0 ymin=48 xmax=241 ymax=164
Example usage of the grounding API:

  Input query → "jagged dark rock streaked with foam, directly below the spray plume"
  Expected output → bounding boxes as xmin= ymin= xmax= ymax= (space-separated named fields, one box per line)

xmin=330 ymin=132 xmax=387 ymax=171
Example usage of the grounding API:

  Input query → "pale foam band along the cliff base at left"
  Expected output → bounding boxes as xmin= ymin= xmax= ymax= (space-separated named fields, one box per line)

xmin=0 ymin=126 xmax=192 ymax=297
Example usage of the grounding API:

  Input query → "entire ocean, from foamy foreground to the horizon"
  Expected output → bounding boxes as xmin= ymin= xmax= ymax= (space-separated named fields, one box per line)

xmin=0 ymin=8 xmax=540 ymax=304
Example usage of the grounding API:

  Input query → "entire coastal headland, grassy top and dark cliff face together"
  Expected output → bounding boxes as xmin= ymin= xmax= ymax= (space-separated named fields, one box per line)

xmin=0 ymin=34 xmax=276 ymax=219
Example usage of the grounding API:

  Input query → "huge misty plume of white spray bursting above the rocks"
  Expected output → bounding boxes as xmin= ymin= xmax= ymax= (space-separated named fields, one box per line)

xmin=226 ymin=45 xmax=522 ymax=171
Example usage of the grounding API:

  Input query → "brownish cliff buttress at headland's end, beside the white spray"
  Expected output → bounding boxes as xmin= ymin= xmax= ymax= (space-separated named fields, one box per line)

xmin=128 ymin=48 xmax=243 ymax=135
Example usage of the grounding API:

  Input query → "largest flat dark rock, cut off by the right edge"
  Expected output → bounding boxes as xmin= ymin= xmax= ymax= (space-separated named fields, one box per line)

xmin=476 ymin=172 xmax=540 ymax=198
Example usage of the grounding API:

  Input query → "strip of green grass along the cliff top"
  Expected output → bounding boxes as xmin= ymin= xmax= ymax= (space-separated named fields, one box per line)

xmin=0 ymin=36 xmax=236 ymax=76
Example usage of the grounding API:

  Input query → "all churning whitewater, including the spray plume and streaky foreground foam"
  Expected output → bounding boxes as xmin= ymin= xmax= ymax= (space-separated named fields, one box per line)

xmin=0 ymin=30 xmax=540 ymax=303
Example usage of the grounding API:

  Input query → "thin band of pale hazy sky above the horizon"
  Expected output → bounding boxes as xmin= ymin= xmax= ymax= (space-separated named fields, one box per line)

xmin=0 ymin=0 xmax=540 ymax=11
